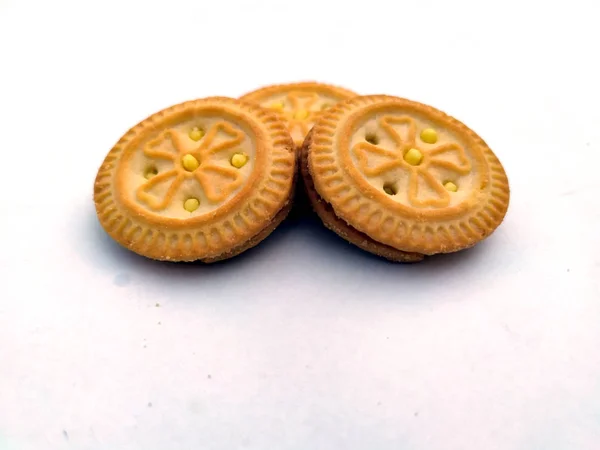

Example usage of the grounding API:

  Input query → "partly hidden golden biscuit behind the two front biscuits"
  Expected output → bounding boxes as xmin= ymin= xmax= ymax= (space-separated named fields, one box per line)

xmin=241 ymin=82 xmax=357 ymax=147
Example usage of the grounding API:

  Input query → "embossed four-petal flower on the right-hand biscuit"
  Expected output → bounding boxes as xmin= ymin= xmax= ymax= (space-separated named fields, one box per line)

xmin=352 ymin=116 xmax=471 ymax=207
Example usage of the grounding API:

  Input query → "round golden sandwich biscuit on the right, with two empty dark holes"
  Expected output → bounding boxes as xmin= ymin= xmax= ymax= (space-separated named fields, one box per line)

xmin=302 ymin=95 xmax=510 ymax=260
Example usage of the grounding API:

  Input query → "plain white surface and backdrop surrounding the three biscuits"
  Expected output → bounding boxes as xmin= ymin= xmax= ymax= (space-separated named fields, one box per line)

xmin=0 ymin=0 xmax=600 ymax=450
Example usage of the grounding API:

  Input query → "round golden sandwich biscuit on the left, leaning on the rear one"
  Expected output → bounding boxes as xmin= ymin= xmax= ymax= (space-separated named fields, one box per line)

xmin=94 ymin=97 xmax=296 ymax=262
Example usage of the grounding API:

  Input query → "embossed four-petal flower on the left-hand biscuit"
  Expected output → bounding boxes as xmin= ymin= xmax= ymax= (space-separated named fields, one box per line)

xmin=137 ymin=122 xmax=244 ymax=210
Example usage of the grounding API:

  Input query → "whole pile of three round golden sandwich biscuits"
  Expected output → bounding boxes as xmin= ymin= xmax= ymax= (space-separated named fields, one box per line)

xmin=94 ymin=83 xmax=509 ymax=262
